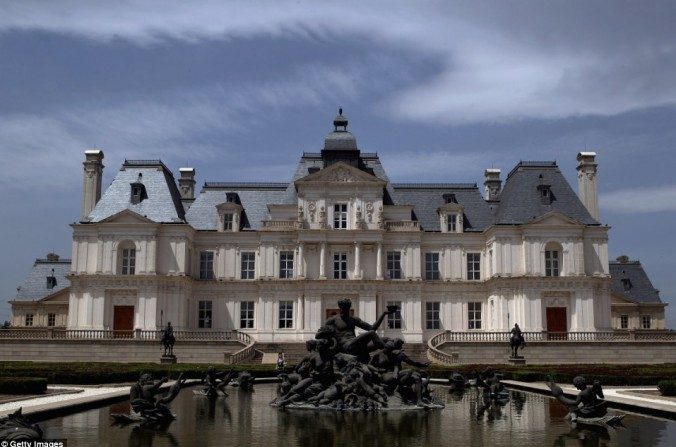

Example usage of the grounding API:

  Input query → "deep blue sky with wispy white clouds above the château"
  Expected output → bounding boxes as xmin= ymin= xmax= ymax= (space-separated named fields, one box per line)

xmin=0 ymin=0 xmax=676 ymax=328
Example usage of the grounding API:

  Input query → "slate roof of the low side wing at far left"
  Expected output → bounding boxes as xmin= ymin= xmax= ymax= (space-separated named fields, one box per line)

xmin=14 ymin=259 xmax=70 ymax=301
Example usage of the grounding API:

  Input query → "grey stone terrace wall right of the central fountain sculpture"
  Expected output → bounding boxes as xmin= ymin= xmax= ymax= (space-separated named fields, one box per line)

xmin=439 ymin=341 xmax=676 ymax=364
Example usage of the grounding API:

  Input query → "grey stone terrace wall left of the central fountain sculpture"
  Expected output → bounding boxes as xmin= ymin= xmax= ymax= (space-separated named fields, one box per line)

xmin=0 ymin=340 xmax=244 ymax=364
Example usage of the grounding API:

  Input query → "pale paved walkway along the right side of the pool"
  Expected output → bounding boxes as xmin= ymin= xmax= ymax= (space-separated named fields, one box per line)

xmin=502 ymin=380 xmax=676 ymax=418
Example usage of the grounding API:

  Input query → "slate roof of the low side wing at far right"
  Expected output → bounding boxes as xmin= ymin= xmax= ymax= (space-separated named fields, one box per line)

xmin=609 ymin=258 xmax=662 ymax=304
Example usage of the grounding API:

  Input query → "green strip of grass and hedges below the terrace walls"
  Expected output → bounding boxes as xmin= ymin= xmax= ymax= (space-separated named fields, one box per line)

xmin=0 ymin=362 xmax=676 ymax=386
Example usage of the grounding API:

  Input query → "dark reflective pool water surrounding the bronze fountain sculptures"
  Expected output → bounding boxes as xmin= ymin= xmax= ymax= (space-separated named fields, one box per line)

xmin=41 ymin=384 xmax=676 ymax=447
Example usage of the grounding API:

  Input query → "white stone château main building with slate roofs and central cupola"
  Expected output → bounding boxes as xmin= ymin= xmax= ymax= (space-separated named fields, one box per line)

xmin=67 ymin=111 xmax=611 ymax=342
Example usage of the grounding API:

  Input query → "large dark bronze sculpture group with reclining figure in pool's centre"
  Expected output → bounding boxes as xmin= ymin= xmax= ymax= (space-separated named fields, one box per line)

xmin=271 ymin=299 xmax=443 ymax=411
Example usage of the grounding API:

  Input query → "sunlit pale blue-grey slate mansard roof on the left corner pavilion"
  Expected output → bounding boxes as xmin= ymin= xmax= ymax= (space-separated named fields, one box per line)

xmin=89 ymin=160 xmax=185 ymax=222
